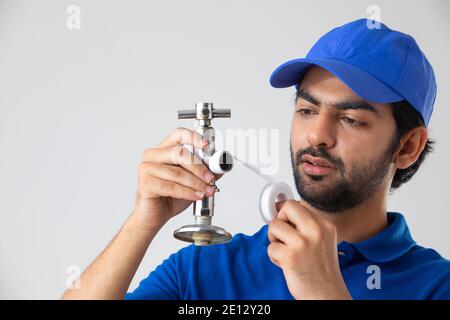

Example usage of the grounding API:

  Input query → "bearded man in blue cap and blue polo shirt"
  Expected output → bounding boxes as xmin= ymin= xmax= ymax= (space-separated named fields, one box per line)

xmin=64 ymin=19 xmax=450 ymax=299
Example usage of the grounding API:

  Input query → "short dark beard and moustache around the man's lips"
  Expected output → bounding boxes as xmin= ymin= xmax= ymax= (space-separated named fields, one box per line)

xmin=291 ymin=144 xmax=393 ymax=213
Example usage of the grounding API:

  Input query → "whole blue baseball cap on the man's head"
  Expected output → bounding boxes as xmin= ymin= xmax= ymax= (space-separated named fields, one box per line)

xmin=270 ymin=19 xmax=436 ymax=127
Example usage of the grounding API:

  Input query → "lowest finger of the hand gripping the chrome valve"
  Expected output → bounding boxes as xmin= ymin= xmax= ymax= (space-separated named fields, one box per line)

xmin=139 ymin=176 xmax=204 ymax=201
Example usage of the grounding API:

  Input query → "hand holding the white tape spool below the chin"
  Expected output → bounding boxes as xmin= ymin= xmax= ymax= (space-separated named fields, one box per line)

xmin=267 ymin=200 xmax=352 ymax=300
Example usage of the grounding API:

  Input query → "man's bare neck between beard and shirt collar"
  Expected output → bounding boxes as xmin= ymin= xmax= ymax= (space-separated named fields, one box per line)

xmin=300 ymin=188 xmax=388 ymax=242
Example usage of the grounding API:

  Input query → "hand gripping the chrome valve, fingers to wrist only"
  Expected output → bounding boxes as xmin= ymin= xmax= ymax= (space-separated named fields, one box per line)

xmin=133 ymin=128 xmax=221 ymax=229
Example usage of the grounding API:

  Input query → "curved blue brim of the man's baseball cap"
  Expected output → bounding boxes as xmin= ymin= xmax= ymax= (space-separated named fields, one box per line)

xmin=270 ymin=58 xmax=404 ymax=103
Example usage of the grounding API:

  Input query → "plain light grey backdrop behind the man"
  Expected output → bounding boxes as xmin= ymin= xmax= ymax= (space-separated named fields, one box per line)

xmin=0 ymin=0 xmax=450 ymax=299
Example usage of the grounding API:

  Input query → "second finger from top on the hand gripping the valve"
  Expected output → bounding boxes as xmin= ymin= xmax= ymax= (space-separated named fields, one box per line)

xmin=143 ymin=146 xmax=215 ymax=183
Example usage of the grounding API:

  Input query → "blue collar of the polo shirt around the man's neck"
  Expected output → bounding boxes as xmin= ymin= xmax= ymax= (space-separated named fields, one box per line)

xmin=339 ymin=212 xmax=416 ymax=262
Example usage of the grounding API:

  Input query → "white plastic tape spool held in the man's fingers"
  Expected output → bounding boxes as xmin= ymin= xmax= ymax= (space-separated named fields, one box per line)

xmin=260 ymin=182 xmax=294 ymax=223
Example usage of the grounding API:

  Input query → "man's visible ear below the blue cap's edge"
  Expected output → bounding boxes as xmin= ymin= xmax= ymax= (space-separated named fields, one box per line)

xmin=394 ymin=126 xmax=428 ymax=169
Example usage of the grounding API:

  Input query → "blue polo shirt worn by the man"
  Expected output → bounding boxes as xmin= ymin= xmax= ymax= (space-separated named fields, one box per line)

xmin=125 ymin=212 xmax=450 ymax=300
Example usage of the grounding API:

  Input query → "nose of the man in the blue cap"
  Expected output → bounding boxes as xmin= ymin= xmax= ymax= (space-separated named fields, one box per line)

xmin=307 ymin=112 xmax=336 ymax=148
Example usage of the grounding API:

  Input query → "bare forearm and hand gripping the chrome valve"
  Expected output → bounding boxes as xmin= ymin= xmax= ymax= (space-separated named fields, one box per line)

xmin=62 ymin=128 xmax=220 ymax=299
